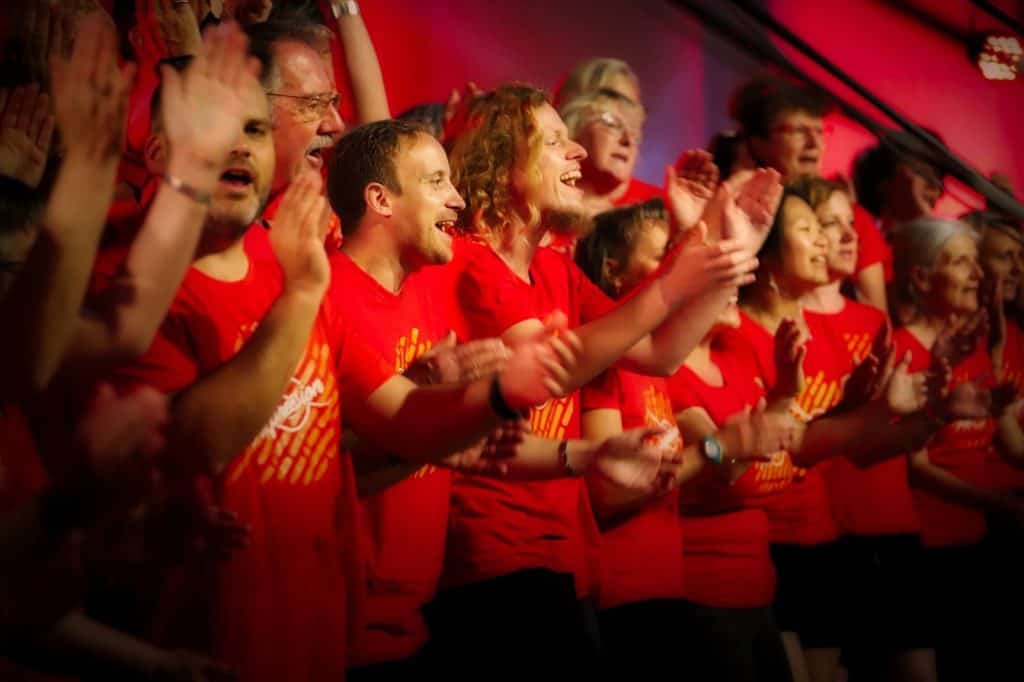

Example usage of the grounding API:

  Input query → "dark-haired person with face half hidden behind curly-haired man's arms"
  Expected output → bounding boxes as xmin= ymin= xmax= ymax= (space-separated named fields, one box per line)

xmin=578 ymin=202 xmax=792 ymax=679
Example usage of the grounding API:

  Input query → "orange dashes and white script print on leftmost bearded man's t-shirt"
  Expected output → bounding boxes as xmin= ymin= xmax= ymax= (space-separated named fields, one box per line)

xmin=227 ymin=325 xmax=340 ymax=485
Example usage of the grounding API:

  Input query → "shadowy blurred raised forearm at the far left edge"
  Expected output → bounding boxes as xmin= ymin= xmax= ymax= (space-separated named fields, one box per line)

xmin=0 ymin=157 xmax=117 ymax=398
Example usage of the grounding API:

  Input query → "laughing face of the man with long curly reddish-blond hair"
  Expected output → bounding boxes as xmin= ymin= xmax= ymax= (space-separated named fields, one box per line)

xmin=512 ymin=103 xmax=587 ymax=231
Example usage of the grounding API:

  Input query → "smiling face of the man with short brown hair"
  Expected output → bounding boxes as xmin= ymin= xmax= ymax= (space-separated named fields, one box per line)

xmin=386 ymin=134 xmax=466 ymax=264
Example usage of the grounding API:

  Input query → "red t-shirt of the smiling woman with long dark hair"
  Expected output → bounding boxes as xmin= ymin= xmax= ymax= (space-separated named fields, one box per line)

xmin=729 ymin=313 xmax=839 ymax=545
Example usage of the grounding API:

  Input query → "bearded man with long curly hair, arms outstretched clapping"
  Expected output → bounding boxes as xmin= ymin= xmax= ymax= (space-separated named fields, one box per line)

xmin=428 ymin=85 xmax=778 ymax=676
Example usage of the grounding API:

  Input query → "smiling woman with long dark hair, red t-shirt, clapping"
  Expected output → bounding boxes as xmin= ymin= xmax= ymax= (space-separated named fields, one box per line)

xmin=734 ymin=182 xmax=934 ymax=680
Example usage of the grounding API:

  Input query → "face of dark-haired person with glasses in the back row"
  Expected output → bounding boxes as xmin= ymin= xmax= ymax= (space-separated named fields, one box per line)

xmin=751 ymin=110 xmax=824 ymax=180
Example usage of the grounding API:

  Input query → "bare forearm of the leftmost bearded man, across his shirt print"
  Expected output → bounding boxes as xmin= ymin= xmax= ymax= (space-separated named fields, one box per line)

xmin=168 ymin=290 xmax=319 ymax=473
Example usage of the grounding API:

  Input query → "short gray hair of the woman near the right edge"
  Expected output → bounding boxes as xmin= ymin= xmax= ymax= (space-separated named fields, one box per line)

xmin=890 ymin=217 xmax=978 ymax=309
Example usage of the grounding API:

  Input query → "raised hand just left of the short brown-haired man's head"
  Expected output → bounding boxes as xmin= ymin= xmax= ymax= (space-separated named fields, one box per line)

xmin=270 ymin=171 xmax=331 ymax=302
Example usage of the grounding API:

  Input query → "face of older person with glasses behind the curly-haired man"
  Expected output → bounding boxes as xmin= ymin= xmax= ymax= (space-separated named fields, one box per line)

xmin=577 ymin=102 xmax=643 ymax=184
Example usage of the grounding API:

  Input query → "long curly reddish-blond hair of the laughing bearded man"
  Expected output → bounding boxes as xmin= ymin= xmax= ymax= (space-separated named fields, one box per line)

xmin=451 ymin=84 xmax=550 ymax=237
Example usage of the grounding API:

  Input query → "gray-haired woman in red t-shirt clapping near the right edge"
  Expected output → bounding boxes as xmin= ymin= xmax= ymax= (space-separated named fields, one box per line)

xmin=893 ymin=218 xmax=1024 ymax=679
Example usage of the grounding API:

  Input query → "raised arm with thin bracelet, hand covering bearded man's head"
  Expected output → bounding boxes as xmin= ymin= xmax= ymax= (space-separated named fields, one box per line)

xmin=65 ymin=19 xmax=258 ymax=374
